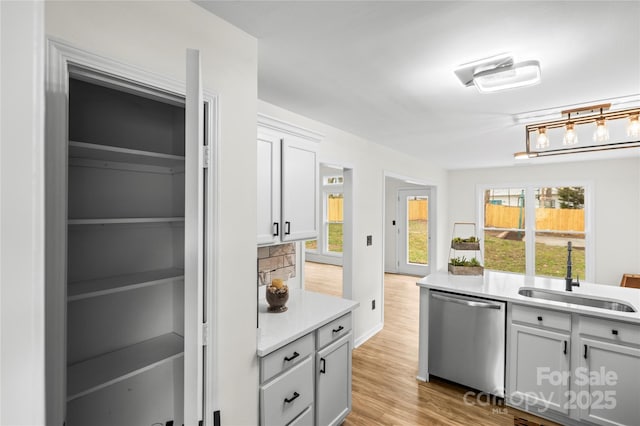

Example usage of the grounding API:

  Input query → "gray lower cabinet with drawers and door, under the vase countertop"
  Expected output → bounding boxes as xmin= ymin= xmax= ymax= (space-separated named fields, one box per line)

xmin=260 ymin=313 xmax=353 ymax=426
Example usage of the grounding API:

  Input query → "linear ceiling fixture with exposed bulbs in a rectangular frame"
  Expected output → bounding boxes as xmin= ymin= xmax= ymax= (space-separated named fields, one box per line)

xmin=514 ymin=103 xmax=640 ymax=159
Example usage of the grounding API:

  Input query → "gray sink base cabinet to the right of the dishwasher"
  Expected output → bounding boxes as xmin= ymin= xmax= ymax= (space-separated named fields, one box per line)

xmin=507 ymin=304 xmax=640 ymax=426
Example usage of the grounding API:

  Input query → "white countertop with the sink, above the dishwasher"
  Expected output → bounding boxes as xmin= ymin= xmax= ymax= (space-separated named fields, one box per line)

xmin=417 ymin=270 xmax=640 ymax=323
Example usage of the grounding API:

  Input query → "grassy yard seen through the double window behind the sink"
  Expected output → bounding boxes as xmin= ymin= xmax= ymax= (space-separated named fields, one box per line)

xmin=484 ymin=234 xmax=585 ymax=278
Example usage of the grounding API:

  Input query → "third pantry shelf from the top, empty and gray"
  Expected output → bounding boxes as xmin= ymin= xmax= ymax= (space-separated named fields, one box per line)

xmin=67 ymin=268 xmax=184 ymax=302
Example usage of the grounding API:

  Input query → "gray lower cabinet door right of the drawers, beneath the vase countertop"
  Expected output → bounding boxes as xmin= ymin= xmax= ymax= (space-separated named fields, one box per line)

xmin=316 ymin=333 xmax=351 ymax=426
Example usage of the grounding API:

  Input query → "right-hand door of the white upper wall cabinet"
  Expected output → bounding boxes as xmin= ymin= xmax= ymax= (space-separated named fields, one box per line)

xmin=282 ymin=136 xmax=318 ymax=241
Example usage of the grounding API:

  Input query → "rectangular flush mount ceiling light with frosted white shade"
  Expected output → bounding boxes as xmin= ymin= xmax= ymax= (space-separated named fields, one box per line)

xmin=455 ymin=53 xmax=541 ymax=93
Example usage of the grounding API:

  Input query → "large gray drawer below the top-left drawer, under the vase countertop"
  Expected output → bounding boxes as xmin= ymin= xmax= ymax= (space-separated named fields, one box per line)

xmin=260 ymin=357 xmax=313 ymax=426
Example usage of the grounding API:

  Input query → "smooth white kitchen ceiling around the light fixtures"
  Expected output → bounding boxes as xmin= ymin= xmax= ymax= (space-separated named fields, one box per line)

xmin=197 ymin=1 xmax=640 ymax=169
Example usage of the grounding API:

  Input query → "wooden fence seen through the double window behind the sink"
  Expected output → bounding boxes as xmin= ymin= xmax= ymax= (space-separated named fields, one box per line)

xmin=485 ymin=204 xmax=584 ymax=232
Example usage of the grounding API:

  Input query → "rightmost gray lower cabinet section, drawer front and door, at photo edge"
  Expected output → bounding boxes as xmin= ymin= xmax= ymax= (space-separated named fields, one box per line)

xmin=572 ymin=316 xmax=640 ymax=425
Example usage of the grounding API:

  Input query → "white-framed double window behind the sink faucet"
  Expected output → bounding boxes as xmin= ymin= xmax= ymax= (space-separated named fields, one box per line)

xmin=482 ymin=186 xmax=588 ymax=278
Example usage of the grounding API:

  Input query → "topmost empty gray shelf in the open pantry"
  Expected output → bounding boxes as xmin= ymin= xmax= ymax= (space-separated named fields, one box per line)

xmin=69 ymin=141 xmax=184 ymax=167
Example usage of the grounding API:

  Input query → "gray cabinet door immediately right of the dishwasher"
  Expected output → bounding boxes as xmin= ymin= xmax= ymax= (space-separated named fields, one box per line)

xmin=508 ymin=324 xmax=571 ymax=414
